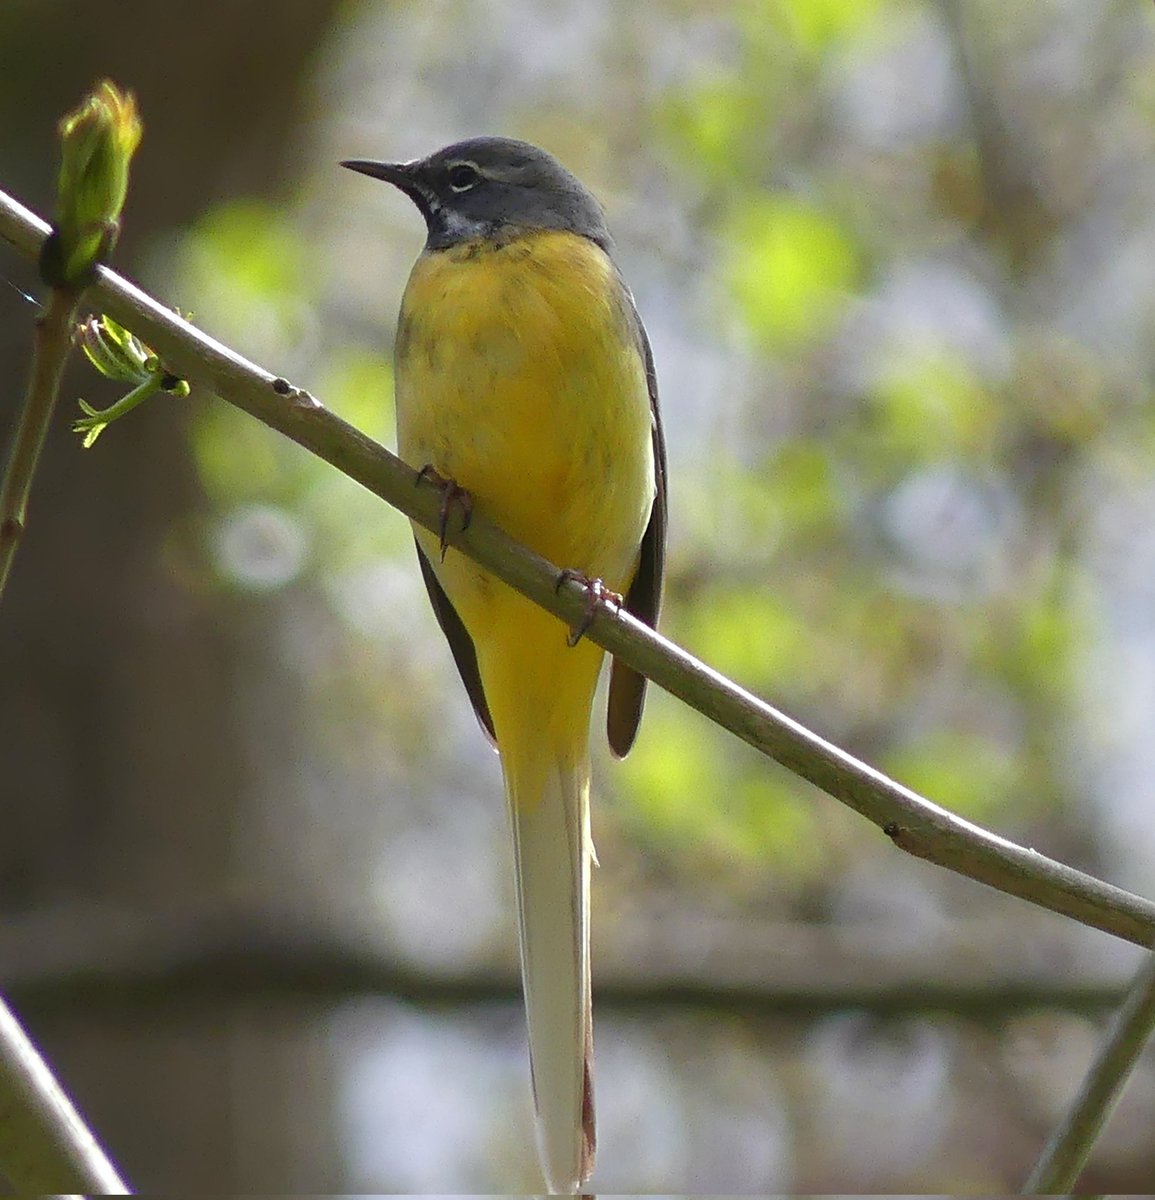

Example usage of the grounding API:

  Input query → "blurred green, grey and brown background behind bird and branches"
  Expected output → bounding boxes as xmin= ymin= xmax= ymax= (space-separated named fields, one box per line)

xmin=0 ymin=0 xmax=1155 ymax=1193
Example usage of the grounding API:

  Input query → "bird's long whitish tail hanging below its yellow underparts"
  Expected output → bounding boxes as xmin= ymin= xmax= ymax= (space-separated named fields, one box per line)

xmin=504 ymin=752 xmax=594 ymax=1193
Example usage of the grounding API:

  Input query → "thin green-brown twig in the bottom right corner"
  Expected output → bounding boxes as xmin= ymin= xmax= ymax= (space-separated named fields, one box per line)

xmin=1023 ymin=954 xmax=1155 ymax=1196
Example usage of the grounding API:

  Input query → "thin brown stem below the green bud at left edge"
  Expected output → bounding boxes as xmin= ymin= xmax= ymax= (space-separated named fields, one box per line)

xmin=0 ymin=288 xmax=79 ymax=598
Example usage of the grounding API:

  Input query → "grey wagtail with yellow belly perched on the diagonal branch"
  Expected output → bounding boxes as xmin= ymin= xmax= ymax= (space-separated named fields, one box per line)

xmin=342 ymin=138 xmax=666 ymax=1193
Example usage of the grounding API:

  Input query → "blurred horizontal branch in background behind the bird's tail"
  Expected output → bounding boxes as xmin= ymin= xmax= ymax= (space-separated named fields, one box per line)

xmin=0 ymin=901 xmax=1125 ymax=1026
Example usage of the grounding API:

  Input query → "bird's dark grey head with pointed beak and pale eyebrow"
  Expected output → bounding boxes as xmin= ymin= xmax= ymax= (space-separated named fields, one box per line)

xmin=341 ymin=138 xmax=611 ymax=252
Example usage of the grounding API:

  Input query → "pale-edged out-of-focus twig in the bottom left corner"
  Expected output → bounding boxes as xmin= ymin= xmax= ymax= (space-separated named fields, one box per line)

xmin=0 ymin=1000 xmax=128 ymax=1195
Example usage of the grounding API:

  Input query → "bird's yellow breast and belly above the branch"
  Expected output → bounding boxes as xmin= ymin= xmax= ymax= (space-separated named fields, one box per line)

xmin=396 ymin=232 xmax=654 ymax=588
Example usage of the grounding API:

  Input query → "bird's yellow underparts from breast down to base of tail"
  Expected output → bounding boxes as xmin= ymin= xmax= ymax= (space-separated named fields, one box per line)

xmin=396 ymin=230 xmax=654 ymax=804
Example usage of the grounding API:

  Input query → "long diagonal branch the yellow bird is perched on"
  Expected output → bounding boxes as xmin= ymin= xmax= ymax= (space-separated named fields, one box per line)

xmin=0 ymin=182 xmax=1155 ymax=947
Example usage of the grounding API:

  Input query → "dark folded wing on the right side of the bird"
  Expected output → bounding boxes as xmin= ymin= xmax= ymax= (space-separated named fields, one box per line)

xmin=602 ymin=292 xmax=666 ymax=758
